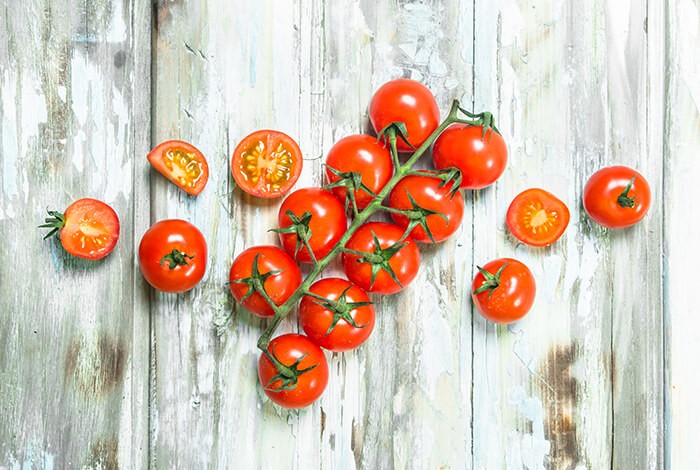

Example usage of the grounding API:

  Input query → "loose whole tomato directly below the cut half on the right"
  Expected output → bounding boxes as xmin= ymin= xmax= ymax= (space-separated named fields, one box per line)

xmin=472 ymin=258 xmax=536 ymax=323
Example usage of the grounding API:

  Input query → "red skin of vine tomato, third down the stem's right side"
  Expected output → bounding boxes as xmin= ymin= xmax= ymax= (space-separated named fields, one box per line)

xmin=342 ymin=222 xmax=420 ymax=295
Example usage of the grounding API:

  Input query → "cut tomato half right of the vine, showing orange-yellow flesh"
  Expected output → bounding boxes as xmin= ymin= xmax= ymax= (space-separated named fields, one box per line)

xmin=506 ymin=188 xmax=569 ymax=246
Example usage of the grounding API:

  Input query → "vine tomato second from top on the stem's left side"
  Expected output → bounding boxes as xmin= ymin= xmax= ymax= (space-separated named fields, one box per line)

xmin=326 ymin=134 xmax=394 ymax=210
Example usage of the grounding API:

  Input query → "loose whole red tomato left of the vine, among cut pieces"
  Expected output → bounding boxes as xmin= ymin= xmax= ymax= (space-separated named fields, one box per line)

xmin=139 ymin=219 xmax=207 ymax=294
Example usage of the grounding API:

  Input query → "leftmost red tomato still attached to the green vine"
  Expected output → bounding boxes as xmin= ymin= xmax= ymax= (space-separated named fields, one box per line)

xmin=229 ymin=245 xmax=301 ymax=317
